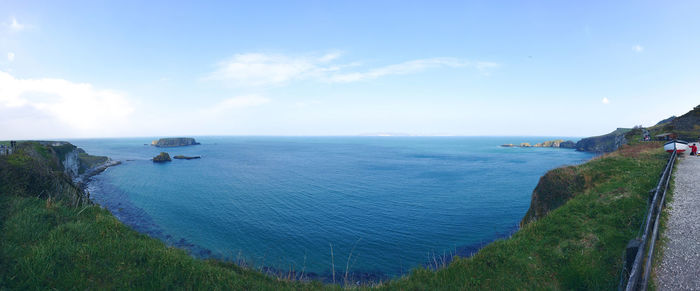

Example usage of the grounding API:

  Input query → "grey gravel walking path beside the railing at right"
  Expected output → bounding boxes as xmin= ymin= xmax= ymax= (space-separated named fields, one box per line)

xmin=656 ymin=154 xmax=700 ymax=290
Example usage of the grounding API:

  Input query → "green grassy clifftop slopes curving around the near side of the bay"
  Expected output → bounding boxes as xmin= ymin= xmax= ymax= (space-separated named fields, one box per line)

xmin=0 ymin=144 xmax=666 ymax=290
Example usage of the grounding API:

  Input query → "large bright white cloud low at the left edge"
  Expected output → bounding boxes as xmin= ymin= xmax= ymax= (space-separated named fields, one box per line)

xmin=0 ymin=71 xmax=133 ymax=136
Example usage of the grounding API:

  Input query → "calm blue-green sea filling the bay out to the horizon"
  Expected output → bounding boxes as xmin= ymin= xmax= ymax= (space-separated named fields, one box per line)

xmin=71 ymin=137 xmax=593 ymax=280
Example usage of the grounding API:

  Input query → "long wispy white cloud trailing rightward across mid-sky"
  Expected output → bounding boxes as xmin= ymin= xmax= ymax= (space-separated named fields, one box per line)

xmin=204 ymin=53 xmax=499 ymax=86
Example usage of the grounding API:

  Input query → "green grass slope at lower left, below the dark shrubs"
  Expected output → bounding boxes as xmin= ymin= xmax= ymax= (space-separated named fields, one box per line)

xmin=0 ymin=197 xmax=328 ymax=290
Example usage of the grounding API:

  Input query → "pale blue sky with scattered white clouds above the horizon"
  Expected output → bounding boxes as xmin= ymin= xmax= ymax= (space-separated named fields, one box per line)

xmin=0 ymin=0 xmax=700 ymax=139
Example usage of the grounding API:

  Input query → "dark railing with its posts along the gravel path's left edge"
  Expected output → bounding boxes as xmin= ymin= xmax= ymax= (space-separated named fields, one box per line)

xmin=620 ymin=150 xmax=677 ymax=291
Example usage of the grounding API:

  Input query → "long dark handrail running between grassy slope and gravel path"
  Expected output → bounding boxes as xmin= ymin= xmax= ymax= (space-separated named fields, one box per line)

xmin=625 ymin=150 xmax=677 ymax=291
